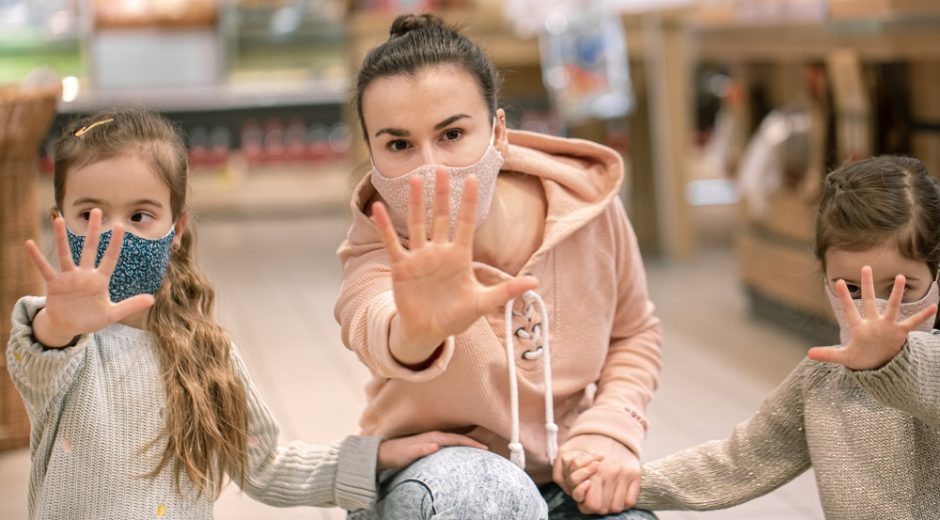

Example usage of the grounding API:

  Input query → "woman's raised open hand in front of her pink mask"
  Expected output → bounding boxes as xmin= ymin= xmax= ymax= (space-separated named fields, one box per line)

xmin=373 ymin=169 xmax=537 ymax=364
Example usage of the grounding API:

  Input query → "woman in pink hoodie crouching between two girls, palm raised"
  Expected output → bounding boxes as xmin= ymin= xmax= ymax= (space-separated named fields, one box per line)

xmin=336 ymin=15 xmax=660 ymax=519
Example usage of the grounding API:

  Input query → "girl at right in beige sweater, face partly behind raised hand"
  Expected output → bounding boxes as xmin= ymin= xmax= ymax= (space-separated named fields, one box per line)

xmin=596 ymin=157 xmax=940 ymax=520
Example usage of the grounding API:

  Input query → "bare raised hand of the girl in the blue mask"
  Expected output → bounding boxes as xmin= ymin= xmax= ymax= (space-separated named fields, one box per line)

xmin=26 ymin=208 xmax=154 ymax=347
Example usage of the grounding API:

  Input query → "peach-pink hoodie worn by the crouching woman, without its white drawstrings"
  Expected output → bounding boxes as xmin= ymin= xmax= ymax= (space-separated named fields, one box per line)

xmin=335 ymin=131 xmax=661 ymax=483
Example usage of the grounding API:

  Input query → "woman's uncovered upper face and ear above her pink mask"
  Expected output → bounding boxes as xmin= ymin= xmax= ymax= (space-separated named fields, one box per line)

xmin=362 ymin=66 xmax=506 ymax=177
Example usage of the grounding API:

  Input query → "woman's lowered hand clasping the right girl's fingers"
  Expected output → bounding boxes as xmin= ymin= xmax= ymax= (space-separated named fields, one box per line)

xmin=554 ymin=435 xmax=640 ymax=515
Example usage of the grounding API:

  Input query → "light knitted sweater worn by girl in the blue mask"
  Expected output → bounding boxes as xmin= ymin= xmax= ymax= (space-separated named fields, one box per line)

xmin=7 ymin=297 xmax=379 ymax=520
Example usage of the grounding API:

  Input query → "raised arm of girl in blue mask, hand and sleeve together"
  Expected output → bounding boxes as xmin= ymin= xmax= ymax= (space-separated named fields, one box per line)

xmin=7 ymin=209 xmax=153 ymax=427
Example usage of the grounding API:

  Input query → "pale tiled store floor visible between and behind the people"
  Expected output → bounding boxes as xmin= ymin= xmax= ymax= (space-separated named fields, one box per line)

xmin=0 ymin=212 xmax=822 ymax=520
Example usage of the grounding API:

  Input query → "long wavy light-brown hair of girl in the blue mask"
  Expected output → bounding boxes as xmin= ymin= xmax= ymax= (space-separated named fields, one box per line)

xmin=53 ymin=109 xmax=248 ymax=497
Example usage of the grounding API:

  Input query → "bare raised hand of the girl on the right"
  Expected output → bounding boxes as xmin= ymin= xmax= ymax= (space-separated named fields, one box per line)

xmin=809 ymin=266 xmax=937 ymax=370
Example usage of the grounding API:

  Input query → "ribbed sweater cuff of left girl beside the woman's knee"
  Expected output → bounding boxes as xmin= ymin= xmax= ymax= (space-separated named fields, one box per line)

xmin=336 ymin=436 xmax=382 ymax=511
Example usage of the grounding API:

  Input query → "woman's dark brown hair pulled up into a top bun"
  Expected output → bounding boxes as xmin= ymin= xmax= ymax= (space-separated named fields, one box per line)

xmin=354 ymin=14 xmax=500 ymax=142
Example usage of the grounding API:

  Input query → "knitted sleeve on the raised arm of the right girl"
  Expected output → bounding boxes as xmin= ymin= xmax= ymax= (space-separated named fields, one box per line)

xmin=851 ymin=331 xmax=940 ymax=429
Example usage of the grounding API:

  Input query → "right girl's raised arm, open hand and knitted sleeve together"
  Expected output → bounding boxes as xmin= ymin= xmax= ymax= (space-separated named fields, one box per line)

xmin=809 ymin=266 xmax=940 ymax=428
